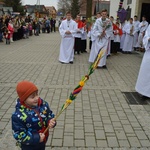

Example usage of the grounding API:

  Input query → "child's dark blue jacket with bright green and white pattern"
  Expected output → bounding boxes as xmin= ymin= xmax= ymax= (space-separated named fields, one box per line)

xmin=12 ymin=98 xmax=54 ymax=145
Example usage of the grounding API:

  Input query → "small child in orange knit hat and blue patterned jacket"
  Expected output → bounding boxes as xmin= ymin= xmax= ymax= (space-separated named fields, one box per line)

xmin=12 ymin=81 xmax=56 ymax=150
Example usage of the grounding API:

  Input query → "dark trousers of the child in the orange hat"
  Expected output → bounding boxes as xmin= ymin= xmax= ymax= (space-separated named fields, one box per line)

xmin=21 ymin=143 xmax=45 ymax=150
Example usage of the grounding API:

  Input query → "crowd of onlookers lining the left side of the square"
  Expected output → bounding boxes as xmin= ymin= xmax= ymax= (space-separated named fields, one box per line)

xmin=0 ymin=15 xmax=56 ymax=44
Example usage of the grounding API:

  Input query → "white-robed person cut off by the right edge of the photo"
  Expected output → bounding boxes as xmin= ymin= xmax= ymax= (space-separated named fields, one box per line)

xmin=135 ymin=25 xmax=150 ymax=98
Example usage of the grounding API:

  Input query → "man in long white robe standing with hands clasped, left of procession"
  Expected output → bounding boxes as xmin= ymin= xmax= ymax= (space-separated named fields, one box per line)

xmin=59 ymin=12 xmax=77 ymax=64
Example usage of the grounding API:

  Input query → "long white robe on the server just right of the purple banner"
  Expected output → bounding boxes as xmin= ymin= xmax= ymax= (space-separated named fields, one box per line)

xmin=122 ymin=23 xmax=134 ymax=52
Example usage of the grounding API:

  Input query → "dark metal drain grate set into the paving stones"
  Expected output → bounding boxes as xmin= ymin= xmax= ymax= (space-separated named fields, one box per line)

xmin=122 ymin=92 xmax=148 ymax=105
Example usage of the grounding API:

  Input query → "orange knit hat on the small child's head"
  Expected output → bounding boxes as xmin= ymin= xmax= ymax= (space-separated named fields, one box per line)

xmin=16 ymin=81 xmax=38 ymax=103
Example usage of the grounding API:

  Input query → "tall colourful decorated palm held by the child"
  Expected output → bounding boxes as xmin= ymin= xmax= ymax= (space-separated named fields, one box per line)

xmin=44 ymin=48 xmax=104 ymax=133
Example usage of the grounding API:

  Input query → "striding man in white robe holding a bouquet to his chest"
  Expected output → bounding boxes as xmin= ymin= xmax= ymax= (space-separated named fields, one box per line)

xmin=93 ymin=10 xmax=113 ymax=68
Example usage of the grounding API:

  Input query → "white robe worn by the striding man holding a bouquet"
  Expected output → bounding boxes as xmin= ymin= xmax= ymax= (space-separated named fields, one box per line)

xmin=93 ymin=18 xmax=113 ymax=67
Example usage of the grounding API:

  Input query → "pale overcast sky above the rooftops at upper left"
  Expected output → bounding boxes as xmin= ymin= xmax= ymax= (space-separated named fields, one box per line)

xmin=22 ymin=0 xmax=58 ymax=9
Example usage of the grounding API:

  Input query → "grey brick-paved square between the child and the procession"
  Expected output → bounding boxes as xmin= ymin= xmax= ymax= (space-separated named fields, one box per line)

xmin=0 ymin=32 xmax=150 ymax=150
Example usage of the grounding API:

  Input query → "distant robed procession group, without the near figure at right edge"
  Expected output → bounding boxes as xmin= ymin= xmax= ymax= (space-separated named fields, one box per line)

xmin=59 ymin=10 xmax=148 ymax=68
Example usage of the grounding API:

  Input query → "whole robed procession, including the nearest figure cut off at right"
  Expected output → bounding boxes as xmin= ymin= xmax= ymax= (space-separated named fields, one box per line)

xmin=59 ymin=10 xmax=150 ymax=98
